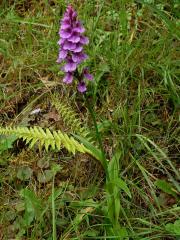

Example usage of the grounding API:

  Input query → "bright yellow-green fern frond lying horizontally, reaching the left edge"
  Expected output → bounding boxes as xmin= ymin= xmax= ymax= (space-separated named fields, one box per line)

xmin=0 ymin=127 xmax=90 ymax=154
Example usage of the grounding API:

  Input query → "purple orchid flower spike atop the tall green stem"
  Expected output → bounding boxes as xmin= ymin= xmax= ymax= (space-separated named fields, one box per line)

xmin=57 ymin=5 xmax=93 ymax=93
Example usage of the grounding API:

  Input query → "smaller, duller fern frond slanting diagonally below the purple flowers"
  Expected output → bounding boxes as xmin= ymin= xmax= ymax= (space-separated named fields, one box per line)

xmin=52 ymin=95 xmax=93 ymax=142
